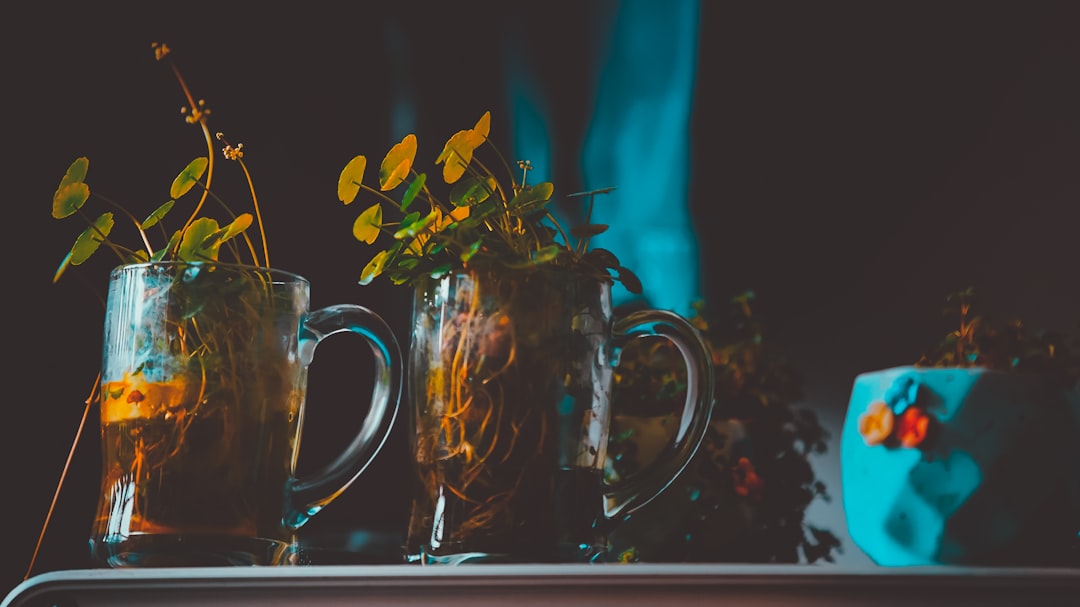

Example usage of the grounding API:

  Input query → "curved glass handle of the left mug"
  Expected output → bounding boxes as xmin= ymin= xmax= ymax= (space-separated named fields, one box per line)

xmin=284 ymin=304 xmax=402 ymax=529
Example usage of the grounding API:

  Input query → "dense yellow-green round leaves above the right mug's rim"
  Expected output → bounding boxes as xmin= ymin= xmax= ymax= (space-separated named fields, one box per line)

xmin=337 ymin=112 xmax=642 ymax=294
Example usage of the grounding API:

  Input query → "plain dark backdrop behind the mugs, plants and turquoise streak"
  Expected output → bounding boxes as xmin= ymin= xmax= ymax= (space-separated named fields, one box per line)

xmin=0 ymin=1 xmax=1080 ymax=588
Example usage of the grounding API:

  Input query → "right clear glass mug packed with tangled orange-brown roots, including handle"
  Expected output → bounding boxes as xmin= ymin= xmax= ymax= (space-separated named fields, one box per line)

xmin=405 ymin=269 xmax=714 ymax=564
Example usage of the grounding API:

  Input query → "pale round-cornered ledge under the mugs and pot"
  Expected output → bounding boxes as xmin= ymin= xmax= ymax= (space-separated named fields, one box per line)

xmin=0 ymin=564 xmax=1080 ymax=607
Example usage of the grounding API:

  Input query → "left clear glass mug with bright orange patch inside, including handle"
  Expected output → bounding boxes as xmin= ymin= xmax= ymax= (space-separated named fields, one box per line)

xmin=90 ymin=261 xmax=403 ymax=567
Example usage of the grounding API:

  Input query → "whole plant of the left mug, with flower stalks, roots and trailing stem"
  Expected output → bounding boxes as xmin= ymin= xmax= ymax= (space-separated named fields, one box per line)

xmin=26 ymin=43 xmax=272 ymax=577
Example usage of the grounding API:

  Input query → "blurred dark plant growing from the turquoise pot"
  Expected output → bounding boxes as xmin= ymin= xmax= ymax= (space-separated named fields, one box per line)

xmin=915 ymin=287 xmax=1080 ymax=386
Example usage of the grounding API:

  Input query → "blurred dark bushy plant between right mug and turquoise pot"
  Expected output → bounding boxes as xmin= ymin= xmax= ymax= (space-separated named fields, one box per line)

xmin=606 ymin=292 xmax=841 ymax=563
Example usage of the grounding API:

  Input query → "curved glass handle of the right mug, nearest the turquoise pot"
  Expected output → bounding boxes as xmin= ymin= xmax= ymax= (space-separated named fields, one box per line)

xmin=604 ymin=309 xmax=715 ymax=520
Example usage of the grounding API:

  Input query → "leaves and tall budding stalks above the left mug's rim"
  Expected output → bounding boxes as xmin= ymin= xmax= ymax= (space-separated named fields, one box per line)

xmin=52 ymin=43 xmax=269 ymax=282
